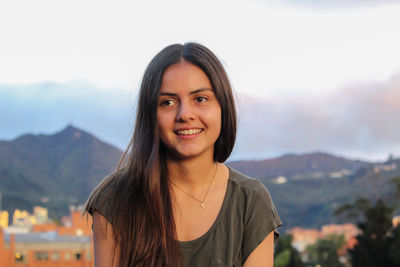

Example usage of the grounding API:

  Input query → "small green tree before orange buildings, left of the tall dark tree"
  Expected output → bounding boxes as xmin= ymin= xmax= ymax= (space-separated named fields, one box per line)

xmin=307 ymin=235 xmax=345 ymax=267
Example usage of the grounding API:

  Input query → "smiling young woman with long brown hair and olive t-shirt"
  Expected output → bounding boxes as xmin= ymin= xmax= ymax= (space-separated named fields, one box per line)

xmin=86 ymin=43 xmax=281 ymax=267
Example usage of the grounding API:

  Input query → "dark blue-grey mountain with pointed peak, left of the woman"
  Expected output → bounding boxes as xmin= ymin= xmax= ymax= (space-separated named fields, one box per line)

xmin=0 ymin=126 xmax=122 ymax=217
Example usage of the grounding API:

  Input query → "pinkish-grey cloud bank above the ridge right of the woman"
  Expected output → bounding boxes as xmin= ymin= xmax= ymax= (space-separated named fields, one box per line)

xmin=235 ymin=74 xmax=400 ymax=159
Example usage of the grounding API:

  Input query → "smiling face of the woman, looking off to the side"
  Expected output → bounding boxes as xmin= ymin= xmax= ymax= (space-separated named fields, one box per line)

xmin=157 ymin=61 xmax=221 ymax=159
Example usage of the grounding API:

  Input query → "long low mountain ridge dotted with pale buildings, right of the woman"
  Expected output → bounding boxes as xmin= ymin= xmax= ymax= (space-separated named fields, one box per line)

xmin=229 ymin=153 xmax=400 ymax=229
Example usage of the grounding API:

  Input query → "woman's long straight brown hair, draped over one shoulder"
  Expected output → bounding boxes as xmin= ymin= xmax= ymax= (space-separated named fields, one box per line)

xmin=85 ymin=43 xmax=236 ymax=267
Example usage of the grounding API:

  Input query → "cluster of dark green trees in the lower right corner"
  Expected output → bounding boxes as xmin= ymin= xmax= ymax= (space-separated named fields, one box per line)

xmin=274 ymin=176 xmax=400 ymax=267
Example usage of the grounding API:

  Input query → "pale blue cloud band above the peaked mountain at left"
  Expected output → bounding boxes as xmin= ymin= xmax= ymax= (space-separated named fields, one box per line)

xmin=0 ymin=80 xmax=136 ymax=148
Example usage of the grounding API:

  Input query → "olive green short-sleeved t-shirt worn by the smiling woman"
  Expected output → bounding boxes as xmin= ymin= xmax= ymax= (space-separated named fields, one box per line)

xmin=93 ymin=167 xmax=282 ymax=267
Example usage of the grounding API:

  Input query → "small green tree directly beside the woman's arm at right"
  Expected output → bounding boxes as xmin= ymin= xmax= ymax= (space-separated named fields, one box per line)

xmin=274 ymin=235 xmax=305 ymax=267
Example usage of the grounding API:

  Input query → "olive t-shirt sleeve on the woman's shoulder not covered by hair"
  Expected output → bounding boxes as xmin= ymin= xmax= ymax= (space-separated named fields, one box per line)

xmin=242 ymin=180 xmax=282 ymax=263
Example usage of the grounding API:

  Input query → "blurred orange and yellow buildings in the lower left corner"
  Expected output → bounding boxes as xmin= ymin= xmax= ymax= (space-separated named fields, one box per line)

xmin=0 ymin=206 xmax=94 ymax=267
